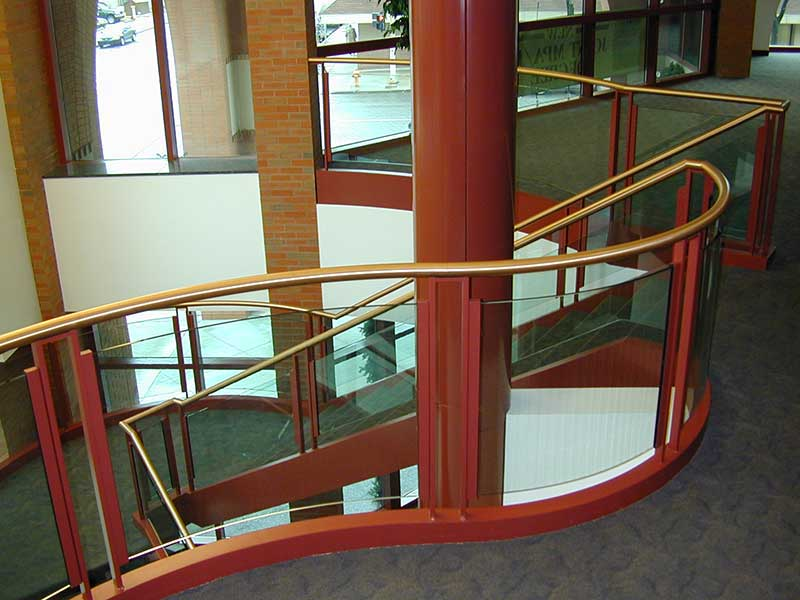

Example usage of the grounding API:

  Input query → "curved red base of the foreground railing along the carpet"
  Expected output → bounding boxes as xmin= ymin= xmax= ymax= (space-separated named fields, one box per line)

xmin=92 ymin=385 xmax=711 ymax=600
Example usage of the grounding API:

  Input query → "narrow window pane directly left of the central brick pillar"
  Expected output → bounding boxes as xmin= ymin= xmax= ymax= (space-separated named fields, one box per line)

xmin=164 ymin=0 xmax=255 ymax=156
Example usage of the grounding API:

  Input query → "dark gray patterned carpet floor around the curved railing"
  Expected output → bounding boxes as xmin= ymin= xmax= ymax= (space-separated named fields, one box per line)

xmin=177 ymin=54 xmax=800 ymax=600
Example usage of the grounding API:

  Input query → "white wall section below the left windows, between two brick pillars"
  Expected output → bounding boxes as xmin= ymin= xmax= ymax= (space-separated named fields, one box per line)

xmin=45 ymin=173 xmax=266 ymax=311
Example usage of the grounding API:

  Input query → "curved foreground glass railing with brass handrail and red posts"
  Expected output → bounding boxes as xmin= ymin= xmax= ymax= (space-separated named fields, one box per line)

xmin=0 ymin=161 xmax=728 ymax=589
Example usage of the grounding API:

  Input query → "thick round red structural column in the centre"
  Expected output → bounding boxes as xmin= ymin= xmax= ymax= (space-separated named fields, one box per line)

xmin=411 ymin=0 xmax=517 ymax=507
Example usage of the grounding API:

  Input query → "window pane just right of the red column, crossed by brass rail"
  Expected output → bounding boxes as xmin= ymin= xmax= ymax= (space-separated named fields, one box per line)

xmin=517 ymin=26 xmax=582 ymax=110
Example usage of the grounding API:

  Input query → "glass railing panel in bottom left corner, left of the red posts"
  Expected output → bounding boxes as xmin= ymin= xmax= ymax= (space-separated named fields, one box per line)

xmin=0 ymin=347 xmax=67 ymax=598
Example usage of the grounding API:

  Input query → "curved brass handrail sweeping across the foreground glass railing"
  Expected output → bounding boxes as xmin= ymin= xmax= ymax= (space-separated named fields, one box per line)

xmin=0 ymin=160 xmax=729 ymax=352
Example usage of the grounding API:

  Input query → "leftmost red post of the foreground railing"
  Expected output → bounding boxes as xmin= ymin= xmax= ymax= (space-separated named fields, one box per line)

xmin=25 ymin=340 xmax=91 ymax=598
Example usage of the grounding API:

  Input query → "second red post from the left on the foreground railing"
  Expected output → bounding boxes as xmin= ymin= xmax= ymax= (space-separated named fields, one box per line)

xmin=69 ymin=331 xmax=130 ymax=590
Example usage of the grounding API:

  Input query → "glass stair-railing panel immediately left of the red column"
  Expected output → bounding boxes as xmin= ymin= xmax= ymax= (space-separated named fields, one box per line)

xmin=314 ymin=305 xmax=416 ymax=444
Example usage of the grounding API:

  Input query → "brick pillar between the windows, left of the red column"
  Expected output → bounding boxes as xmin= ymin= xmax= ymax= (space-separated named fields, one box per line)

xmin=247 ymin=0 xmax=342 ymax=520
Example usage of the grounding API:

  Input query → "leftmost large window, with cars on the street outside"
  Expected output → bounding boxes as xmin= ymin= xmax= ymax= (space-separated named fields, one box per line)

xmin=51 ymin=0 xmax=166 ymax=160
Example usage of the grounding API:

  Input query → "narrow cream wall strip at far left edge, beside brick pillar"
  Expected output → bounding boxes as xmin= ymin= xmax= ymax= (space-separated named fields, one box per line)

xmin=0 ymin=78 xmax=41 ymax=338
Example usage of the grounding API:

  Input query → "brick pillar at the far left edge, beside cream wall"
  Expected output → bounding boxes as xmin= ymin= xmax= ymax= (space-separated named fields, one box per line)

xmin=0 ymin=0 xmax=64 ymax=319
